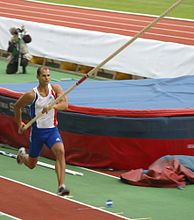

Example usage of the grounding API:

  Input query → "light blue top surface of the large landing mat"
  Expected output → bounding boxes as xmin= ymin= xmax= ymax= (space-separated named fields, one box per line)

xmin=0 ymin=76 xmax=194 ymax=110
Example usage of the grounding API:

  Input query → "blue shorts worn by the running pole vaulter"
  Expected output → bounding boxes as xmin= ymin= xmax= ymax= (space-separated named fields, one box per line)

xmin=29 ymin=127 xmax=62 ymax=158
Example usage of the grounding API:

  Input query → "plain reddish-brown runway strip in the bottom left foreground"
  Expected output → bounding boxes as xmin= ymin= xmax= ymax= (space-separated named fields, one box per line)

xmin=0 ymin=177 xmax=126 ymax=220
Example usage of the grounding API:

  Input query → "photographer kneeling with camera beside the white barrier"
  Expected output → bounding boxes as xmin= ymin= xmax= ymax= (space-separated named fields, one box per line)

xmin=6 ymin=26 xmax=32 ymax=74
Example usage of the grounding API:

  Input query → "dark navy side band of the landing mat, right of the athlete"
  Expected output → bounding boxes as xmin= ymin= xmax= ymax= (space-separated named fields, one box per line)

xmin=58 ymin=112 xmax=194 ymax=139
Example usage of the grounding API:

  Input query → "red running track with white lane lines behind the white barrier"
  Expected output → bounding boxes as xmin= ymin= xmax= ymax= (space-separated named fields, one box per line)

xmin=0 ymin=0 xmax=194 ymax=45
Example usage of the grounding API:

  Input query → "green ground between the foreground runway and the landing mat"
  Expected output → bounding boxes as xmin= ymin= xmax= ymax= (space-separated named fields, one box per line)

xmin=0 ymin=144 xmax=194 ymax=220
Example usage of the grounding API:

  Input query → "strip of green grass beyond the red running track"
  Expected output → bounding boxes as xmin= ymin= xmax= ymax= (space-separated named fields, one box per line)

xmin=39 ymin=0 xmax=194 ymax=19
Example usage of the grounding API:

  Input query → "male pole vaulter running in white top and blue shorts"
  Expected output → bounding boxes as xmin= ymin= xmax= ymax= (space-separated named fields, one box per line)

xmin=14 ymin=66 xmax=70 ymax=196
